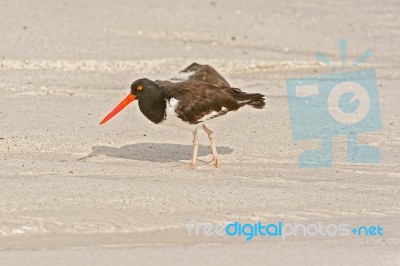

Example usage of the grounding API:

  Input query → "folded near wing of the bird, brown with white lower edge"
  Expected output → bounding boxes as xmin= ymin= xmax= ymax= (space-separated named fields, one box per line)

xmin=162 ymin=80 xmax=242 ymax=124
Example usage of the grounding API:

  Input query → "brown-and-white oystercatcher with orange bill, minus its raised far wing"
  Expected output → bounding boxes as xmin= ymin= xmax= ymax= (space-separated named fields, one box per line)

xmin=100 ymin=67 xmax=265 ymax=169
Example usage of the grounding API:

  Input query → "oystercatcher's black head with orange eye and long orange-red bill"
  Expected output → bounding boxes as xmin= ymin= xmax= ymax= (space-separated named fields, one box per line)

xmin=100 ymin=78 xmax=160 ymax=125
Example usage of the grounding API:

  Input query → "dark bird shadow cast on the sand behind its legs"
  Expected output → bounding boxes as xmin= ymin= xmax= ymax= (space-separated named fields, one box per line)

xmin=78 ymin=143 xmax=233 ymax=162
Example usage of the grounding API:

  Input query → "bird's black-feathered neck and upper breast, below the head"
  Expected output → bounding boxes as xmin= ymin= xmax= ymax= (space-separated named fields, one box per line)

xmin=139 ymin=89 xmax=167 ymax=124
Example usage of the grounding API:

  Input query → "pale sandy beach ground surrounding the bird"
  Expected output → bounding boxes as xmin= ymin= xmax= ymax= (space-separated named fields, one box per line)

xmin=0 ymin=0 xmax=400 ymax=265
